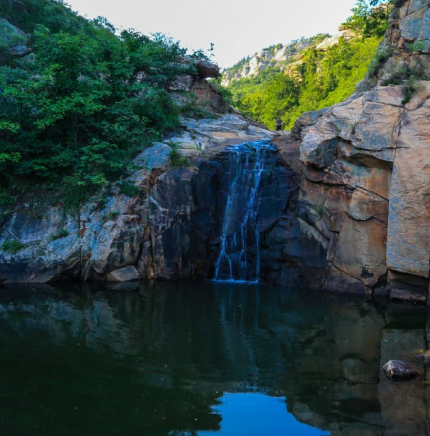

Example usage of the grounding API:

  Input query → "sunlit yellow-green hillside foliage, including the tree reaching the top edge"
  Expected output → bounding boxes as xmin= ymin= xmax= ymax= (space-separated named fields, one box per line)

xmin=223 ymin=0 xmax=392 ymax=129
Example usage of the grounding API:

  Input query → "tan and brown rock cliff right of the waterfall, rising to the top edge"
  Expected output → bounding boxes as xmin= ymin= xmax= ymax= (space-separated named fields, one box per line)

xmin=268 ymin=0 xmax=430 ymax=303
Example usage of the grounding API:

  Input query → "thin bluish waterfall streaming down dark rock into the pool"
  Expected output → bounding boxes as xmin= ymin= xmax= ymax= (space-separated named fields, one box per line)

xmin=215 ymin=141 xmax=274 ymax=283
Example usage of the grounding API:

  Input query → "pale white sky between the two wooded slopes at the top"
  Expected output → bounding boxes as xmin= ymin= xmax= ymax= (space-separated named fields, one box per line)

xmin=67 ymin=0 xmax=356 ymax=68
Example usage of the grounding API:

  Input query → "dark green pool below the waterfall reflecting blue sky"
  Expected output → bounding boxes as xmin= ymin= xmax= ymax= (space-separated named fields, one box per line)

xmin=0 ymin=282 xmax=430 ymax=436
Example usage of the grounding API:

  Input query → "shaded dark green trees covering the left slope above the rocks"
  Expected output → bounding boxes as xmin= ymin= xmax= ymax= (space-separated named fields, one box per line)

xmin=0 ymin=0 xmax=203 ymax=204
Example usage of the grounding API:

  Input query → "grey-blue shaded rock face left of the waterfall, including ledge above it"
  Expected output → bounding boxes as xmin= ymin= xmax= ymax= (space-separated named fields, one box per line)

xmin=0 ymin=115 xmax=282 ymax=283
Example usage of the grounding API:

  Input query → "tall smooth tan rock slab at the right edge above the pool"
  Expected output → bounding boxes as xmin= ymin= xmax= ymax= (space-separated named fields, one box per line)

xmin=387 ymin=95 xmax=430 ymax=278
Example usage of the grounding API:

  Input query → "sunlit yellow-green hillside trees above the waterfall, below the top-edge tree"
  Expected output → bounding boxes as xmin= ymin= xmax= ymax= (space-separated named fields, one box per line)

xmin=227 ymin=37 xmax=380 ymax=129
